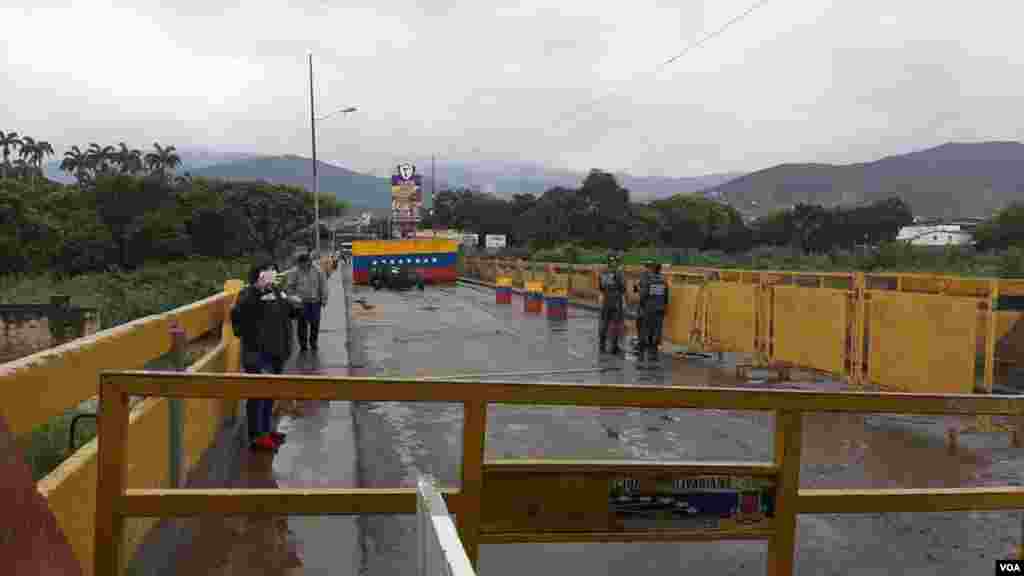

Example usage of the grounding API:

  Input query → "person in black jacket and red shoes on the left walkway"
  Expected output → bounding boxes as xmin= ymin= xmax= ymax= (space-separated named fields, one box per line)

xmin=231 ymin=263 xmax=295 ymax=450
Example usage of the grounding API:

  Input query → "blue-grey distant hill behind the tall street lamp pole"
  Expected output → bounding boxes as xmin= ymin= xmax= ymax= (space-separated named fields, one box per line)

xmin=191 ymin=155 xmax=391 ymax=210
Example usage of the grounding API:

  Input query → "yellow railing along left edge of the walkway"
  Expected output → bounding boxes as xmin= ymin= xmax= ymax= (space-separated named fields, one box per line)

xmin=0 ymin=280 xmax=242 ymax=575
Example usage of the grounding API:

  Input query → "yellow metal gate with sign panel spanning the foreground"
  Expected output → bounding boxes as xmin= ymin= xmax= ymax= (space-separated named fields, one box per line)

xmin=94 ymin=371 xmax=1024 ymax=576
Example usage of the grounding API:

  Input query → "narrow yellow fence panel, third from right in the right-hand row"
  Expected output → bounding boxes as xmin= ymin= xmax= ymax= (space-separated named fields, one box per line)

xmin=704 ymin=282 xmax=759 ymax=354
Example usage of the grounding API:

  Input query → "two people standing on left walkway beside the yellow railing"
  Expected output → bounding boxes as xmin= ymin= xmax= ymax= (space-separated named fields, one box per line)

xmin=231 ymin=253 xmax=329 ymax=451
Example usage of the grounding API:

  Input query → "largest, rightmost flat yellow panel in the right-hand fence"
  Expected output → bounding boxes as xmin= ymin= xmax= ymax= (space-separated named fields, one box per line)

xmin=867 ymin=292 xmax=978 ymax=394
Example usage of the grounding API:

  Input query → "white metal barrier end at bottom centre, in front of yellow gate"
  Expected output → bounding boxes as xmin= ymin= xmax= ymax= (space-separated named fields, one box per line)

xmin=416 ymin=477 xmax=476 ymax=576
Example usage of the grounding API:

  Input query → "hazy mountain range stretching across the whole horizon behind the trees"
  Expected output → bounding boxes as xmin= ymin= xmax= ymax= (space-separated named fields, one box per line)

xmin=39 ymin=141 xmax=1024 ymax=217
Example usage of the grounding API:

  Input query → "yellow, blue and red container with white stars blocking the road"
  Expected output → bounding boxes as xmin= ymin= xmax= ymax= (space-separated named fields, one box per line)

xmin=352 ymin=238 xmax=459 ymax=284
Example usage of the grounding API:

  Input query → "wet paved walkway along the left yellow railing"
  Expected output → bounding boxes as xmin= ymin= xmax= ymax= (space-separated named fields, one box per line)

xmin=129 ymin=271 xmax=362 ymax=576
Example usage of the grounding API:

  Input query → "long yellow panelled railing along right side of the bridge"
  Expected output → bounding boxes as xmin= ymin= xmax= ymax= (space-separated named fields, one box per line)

xmin=467 ymin=258 xmax=1024 ymax=393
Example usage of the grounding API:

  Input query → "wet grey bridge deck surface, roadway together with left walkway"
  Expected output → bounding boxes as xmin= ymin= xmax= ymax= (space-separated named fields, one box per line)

xmin=146 ymin=266 xmax=1024 ymax=576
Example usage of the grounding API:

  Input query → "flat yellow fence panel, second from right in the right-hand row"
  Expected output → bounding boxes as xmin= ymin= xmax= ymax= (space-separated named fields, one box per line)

xmin=771 ymin=286 xmax=849 ymax=374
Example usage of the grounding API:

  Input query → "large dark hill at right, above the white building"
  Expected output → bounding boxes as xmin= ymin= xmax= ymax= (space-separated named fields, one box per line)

xmin=701 ymin=141 xmax=1024 ymax=218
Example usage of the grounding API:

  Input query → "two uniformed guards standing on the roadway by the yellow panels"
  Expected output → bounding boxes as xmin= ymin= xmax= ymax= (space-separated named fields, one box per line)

xmin=598 ymin=254 xmax=669 ymax=361
